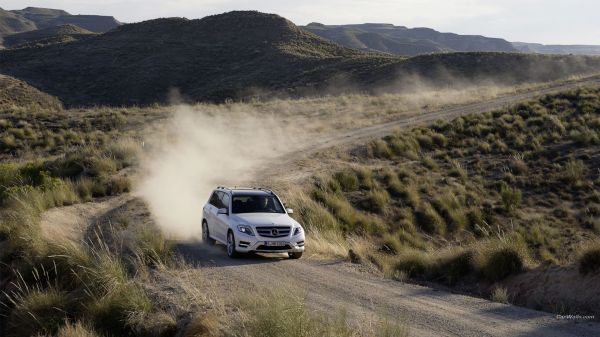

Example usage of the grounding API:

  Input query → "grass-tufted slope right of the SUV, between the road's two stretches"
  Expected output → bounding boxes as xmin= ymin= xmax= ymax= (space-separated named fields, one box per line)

xmin=296 ymin=89 xmax=600 ymax=298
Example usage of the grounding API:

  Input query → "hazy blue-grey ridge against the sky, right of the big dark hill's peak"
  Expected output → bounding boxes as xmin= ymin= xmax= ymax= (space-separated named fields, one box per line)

xmin=302 ymin=23 xmax=517 ymax=56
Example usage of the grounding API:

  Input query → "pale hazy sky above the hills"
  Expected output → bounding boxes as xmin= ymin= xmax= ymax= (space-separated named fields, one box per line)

xmin=0 ymin=0 xmax=600 ymax=45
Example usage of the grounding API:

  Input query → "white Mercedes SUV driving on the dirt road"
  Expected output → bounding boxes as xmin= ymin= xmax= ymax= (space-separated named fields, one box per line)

xmin=202 ymin=187 xmax=304 ymax=259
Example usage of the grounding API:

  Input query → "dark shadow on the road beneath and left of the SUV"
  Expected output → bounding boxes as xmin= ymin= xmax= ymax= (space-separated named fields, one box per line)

xmin=175 ymin=241 xmax=288 ymax=267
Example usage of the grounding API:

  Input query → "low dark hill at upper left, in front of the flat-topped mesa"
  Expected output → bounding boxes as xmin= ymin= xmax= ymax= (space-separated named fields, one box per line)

xmin=4 ymin=25 xmax=95 ymax=48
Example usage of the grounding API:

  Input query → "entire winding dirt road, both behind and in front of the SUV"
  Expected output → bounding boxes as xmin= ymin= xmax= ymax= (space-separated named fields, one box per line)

xmin=46 ymin=78 xmax=600 ymax=337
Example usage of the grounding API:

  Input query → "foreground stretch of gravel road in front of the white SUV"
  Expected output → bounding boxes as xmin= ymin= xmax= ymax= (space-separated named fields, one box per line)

xmin=179 ymin=243 xmax=600 ymax=337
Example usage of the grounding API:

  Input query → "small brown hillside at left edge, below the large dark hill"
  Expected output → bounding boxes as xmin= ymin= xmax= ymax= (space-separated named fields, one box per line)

xmin=0 ymin=75 xmax=62 ymax=109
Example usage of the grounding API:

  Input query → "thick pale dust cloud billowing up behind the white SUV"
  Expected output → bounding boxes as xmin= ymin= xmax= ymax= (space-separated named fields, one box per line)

xmin=136 ymin=105 xmax=300 ymax=239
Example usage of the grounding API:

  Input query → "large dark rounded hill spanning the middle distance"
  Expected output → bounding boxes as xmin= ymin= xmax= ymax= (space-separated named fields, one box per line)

xmin=0 ymin=11 xmax=600 ymax=106
